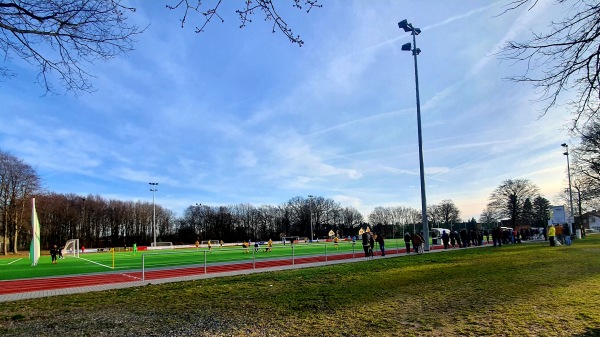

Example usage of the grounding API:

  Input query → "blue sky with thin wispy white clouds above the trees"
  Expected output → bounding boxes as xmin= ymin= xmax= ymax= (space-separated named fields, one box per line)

xmin=0 ymin=0 xmax=569 ymax=219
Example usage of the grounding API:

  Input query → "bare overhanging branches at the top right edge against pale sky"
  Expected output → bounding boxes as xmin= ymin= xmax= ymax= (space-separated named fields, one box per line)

xmin=500 ymin=0 xmax=600 ymax=127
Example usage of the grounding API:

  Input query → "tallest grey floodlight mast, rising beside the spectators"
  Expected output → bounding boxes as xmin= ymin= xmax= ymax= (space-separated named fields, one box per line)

xmin=398 ymin=19 xmax=429 ymax=251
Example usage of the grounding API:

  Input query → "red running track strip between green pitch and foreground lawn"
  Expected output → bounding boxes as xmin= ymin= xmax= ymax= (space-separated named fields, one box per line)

xmin=0 ymin=246 xmax=450 ymax=295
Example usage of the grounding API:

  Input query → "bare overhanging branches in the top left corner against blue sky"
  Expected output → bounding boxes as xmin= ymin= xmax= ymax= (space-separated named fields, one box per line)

xmin=0 ymin=0 xmax=143 ymax=92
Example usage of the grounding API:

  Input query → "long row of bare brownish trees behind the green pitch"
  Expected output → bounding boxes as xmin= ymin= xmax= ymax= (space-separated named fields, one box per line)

xmin=21 ymin=193 xmax=363 ymax=249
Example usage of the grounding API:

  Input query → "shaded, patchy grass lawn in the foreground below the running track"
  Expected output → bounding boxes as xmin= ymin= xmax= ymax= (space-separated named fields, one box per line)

xmin=0 ymin=235 xmax=600 ymax=337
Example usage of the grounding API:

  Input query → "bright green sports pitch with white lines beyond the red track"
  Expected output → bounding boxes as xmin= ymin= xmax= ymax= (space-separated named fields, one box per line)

xmin=0 ymin=240 xmax=404 ymax=280
